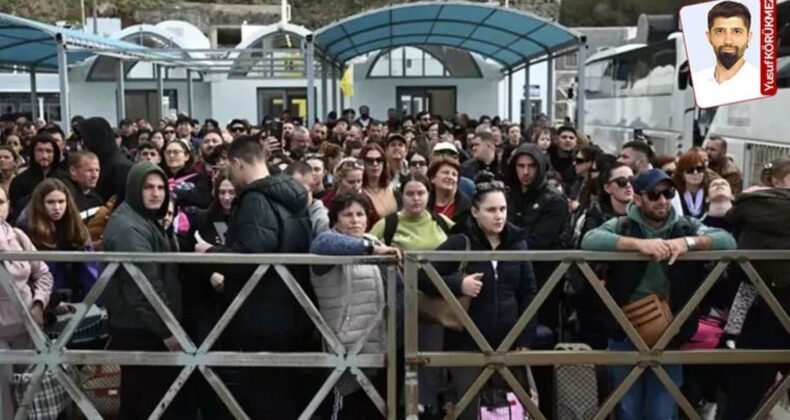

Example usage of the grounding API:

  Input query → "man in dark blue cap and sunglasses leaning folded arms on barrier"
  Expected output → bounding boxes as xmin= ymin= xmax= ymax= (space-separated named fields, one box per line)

xmin=582 ymin=169 xmax=735 ymax=420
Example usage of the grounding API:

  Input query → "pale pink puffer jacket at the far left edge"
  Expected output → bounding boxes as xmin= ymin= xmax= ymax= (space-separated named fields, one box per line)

xmin=0 ymin=221 xmax=52 ymax=338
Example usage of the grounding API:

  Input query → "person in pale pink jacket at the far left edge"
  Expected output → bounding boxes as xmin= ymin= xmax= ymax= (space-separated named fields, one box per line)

xmin=0 ymin=188 xmax=52 ymax=419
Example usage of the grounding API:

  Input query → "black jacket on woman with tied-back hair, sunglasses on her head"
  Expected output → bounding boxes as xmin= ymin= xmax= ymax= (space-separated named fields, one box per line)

xmin=419 ymin=219 xmax=536 ymax=350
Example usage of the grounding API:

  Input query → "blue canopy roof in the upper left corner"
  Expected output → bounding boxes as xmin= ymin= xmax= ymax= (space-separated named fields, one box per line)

xmin=0 ymin=13 xmax=172 ymax=70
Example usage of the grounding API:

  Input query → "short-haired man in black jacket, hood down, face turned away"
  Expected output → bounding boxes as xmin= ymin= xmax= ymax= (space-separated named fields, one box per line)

xmin=195 ymin=136 xmax=320 ymax=419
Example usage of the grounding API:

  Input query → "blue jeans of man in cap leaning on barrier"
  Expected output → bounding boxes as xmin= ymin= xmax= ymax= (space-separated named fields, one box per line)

xmin=609 ymin=338 xmax=683 ymax=420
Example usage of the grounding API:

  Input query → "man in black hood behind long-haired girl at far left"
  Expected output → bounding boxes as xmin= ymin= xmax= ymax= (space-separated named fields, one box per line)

xmin=8 ymin=133 xmax=68 ymax=221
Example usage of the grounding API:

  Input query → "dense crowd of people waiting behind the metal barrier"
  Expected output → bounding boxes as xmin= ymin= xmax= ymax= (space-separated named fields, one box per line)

xmin=0 ymin=106 xmax=790 ymax=420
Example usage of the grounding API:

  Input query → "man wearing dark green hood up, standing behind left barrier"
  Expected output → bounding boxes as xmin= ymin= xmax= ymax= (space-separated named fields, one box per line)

xmin=103 ymin=162 xmax=189 ymax=419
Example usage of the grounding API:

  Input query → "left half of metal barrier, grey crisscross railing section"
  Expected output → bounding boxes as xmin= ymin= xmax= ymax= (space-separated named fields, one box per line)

xmin=0 ymin=252 xmax=397 ymax=420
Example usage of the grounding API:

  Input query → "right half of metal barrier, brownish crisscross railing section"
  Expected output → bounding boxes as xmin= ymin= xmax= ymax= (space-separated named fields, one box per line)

xmin=404 ymin=251 xmax=790 ymax=420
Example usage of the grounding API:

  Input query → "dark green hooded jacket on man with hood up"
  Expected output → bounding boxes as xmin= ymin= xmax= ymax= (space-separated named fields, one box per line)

xmin=103 ymin=162 xmax=181 ymax=339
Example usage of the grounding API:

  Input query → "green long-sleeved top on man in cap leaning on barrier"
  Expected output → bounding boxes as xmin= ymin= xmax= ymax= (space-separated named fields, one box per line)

xmin=582 ymin=204 xmax=736 ymax=301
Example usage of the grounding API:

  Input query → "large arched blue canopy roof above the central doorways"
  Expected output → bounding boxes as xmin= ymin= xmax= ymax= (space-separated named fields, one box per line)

xmin=315 ymin=1 xmax=581 ymax=68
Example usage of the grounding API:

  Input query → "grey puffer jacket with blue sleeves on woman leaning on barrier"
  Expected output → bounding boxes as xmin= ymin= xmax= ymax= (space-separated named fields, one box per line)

xmin=310 ymin=229 xmax=386 ymax=353
